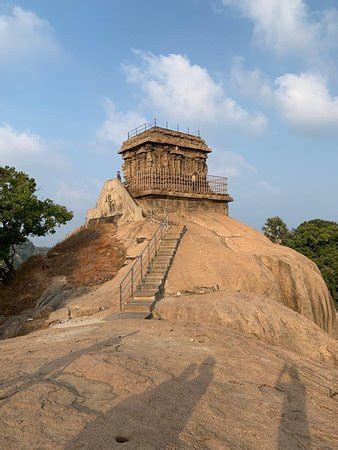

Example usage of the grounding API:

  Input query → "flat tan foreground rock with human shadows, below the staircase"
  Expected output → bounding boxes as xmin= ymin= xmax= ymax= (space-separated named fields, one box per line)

xmin=0 ymin=315 xmax=338 ymax=450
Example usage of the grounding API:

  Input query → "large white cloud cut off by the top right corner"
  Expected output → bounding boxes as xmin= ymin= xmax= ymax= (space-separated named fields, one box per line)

xmin=223 ymin=0 xmax=338 ymax=55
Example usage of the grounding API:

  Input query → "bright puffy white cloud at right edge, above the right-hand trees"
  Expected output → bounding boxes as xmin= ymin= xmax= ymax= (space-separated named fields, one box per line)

xmin=275 ymin=73 xmax=338 ymax=132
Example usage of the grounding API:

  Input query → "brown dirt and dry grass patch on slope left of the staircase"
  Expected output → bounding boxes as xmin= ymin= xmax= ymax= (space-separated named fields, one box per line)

xmin=0 ymin=224 xmax=125 ymax=316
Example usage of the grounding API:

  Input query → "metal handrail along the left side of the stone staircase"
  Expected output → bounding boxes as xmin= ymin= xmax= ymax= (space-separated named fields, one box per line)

xmin=120 ymin=216 xmax=169 ymax=312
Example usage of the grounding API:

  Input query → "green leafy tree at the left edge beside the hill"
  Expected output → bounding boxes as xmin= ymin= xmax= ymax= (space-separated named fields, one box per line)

xmin=0 ymin=166 xmax=73 ymax=284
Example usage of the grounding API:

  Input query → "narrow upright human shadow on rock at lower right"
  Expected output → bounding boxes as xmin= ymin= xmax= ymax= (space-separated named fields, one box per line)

xmin=275 ymin=363 xmax=311 ymax=450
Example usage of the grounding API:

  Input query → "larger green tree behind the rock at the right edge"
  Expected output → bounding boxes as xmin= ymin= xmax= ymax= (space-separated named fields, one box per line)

xmin=287 ymin=219 xmax=338 ymax=302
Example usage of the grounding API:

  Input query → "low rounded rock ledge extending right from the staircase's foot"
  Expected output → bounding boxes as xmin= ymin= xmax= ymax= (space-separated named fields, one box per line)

xmin=153 ymin=291 xmax=337 ymax=365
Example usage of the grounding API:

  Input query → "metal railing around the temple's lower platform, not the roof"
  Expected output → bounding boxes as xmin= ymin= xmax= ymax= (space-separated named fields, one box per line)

xmin=128 ymin=169 xmax=228 ymax=195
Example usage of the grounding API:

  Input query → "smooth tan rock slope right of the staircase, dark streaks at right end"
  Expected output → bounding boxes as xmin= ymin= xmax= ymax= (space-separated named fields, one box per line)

xmin=166 ymin=213 xmax=335 ymax=334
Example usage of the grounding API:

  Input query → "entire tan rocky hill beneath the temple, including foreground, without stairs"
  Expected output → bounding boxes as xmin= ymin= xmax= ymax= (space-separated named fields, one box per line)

xmin=0 ymin=214 xmax=338 ymax=449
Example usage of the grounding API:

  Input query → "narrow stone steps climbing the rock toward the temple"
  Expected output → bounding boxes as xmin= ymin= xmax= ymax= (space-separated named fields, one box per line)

xmin=123 ymin=226 xmax=186 ymax=317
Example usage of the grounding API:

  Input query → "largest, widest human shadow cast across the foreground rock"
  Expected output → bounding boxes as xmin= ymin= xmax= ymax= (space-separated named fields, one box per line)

xmin=65 ymin=357 xmax=215 ymax=449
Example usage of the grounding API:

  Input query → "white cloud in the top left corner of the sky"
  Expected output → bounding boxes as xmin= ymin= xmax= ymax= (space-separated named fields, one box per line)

xmin=0 ymin=6 xmax=60 ymax=65
